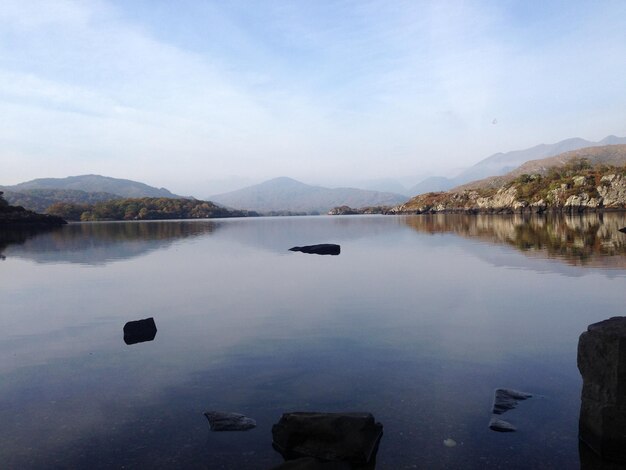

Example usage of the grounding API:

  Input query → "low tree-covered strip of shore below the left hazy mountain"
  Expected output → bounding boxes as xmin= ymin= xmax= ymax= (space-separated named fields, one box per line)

xmin=47 ymin=197 xmax=257 ymax=221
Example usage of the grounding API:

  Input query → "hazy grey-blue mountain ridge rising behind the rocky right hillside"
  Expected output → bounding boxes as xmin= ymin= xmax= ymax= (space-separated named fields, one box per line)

xmin=410 ymin=135 xmax=626 ymax=195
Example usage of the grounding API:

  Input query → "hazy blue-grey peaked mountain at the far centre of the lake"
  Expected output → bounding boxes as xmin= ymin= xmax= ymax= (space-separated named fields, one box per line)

xmin=209 ymin=177 xmax=406 ymax=213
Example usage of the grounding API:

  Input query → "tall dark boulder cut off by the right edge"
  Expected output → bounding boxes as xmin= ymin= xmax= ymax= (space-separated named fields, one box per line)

xmin=578 ymin=317 xmax=626 ymax=463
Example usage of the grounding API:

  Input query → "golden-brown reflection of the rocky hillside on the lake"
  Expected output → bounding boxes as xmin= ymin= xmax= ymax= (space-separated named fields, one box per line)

xmin=403 ymin=213 xmax=626 ymax=269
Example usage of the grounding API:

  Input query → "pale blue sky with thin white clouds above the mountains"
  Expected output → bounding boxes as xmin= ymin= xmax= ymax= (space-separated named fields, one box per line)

xmin=0 ymin=0 xmax=626 ymax=196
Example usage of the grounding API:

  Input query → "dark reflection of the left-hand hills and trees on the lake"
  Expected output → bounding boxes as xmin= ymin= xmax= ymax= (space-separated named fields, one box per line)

xmin=0 ymin=221 xmax=217 ymax=264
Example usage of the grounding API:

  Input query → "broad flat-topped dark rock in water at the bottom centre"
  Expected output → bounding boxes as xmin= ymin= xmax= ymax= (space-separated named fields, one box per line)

xmin=272 ymin=412 xmax=383 ymax=468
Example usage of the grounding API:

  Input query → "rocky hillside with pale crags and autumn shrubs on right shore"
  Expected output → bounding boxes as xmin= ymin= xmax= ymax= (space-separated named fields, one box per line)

xmin=391 ymin=155 xmax=626 ymax=214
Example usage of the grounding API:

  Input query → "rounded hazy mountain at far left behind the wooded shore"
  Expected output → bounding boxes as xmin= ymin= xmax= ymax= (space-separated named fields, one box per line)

xmin=4 ymin=175 xmax=181 ymax=198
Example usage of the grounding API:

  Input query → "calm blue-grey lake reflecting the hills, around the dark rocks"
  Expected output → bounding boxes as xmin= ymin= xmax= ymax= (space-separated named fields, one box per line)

xmin=0 ymin=213 xmax=626 ymax=469
